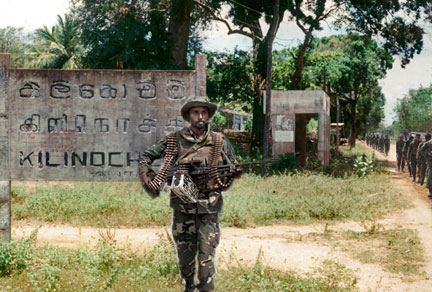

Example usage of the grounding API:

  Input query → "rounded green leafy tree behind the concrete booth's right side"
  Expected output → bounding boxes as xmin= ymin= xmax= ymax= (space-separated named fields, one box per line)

xmin=312 ymin=34 xmax=393 ymax=146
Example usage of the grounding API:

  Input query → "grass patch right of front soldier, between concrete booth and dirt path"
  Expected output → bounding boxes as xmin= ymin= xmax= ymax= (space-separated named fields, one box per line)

xmin=222 ymin=173 xmax=402 ymax=227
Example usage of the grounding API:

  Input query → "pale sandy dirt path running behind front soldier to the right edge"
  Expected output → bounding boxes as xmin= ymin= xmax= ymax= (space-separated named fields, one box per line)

xmin=9 ymin=143 xmax=432 ymax=292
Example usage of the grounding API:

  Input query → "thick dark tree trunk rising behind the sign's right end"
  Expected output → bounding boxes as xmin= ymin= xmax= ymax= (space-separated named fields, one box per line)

xmin=168 ymin=0 xmax=193 ymax=69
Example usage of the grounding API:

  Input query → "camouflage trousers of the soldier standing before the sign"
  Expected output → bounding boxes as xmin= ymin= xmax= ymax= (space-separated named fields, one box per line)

xmin=172 ymin=211 xmax=220 ymax=291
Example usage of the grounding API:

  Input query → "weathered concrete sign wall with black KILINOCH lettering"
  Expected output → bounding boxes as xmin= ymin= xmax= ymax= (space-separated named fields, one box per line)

xmin=5 ymin=56 xmax=206 ymax=181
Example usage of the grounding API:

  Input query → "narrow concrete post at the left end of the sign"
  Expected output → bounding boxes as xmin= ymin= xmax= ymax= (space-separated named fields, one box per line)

xmin=0 ymin=53 xmax=11 ymax=241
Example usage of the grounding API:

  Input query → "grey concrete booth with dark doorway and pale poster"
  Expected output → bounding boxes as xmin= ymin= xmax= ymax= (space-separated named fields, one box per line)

xmin=271 ymin=90 xmax=330 ymax=165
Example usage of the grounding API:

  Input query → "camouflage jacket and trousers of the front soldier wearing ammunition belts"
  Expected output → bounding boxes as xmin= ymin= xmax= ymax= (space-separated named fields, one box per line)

xmin=140 ymin=125 xmax=237 ymax=291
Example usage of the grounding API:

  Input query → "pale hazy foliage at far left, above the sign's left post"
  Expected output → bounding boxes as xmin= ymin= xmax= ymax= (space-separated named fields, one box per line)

xmin=0 ymin=26 xmax=29 ymax=68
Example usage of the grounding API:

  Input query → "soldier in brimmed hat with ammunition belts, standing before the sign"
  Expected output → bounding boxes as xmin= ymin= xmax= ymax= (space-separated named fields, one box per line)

xmin=139 ymin=97 xmax=241 ymax=292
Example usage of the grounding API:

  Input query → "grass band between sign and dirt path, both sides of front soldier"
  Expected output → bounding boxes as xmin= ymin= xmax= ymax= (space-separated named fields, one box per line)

xmin=12 ymin=145 xmax=406 ymax=227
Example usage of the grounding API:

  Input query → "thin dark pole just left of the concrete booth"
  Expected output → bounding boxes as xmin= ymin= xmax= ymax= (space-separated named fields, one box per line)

xmin=261 ymin=0 xmax=279 ymax=176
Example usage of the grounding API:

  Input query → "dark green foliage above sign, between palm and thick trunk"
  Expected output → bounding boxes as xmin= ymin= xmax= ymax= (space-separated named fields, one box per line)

xmin=72 ymin=0 xmax=170 ymax=69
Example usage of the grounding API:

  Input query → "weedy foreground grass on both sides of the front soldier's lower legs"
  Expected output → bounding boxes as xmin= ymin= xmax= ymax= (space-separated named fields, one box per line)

xmin=0 ymin=237 xmax=357 ymax=292
